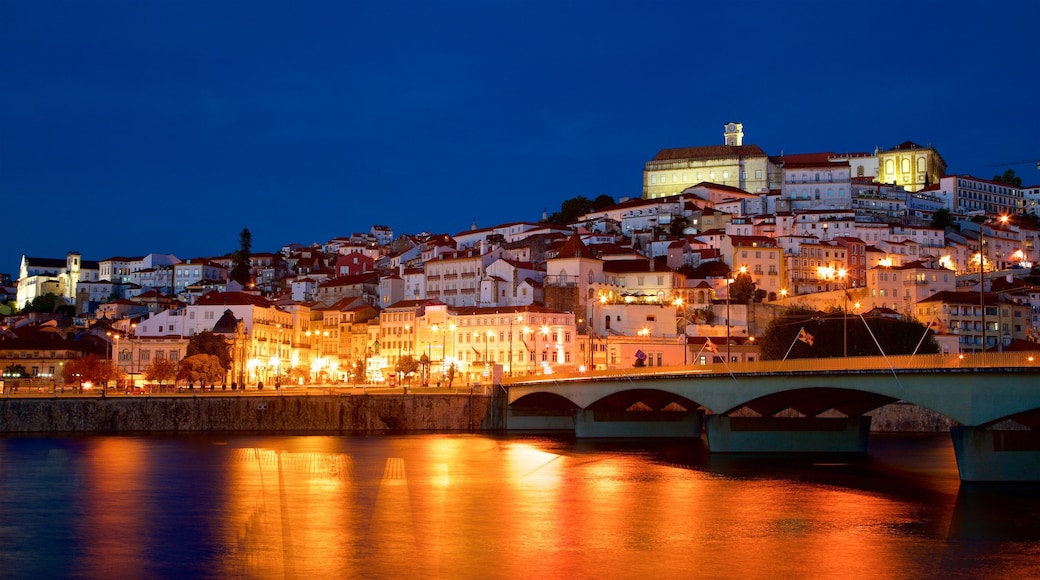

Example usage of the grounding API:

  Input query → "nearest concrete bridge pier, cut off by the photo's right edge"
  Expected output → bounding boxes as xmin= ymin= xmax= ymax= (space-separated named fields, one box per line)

xmin=950 ymin=427 xmax=1040 ymax=481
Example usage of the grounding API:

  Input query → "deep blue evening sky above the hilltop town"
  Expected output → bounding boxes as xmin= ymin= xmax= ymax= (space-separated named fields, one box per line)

xmin=0 ymin=0 xmax=1040 ymax=274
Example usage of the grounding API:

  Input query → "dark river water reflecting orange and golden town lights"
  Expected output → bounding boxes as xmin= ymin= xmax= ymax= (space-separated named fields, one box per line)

xmin=0 ymin=433 xmax=1040 ymax=580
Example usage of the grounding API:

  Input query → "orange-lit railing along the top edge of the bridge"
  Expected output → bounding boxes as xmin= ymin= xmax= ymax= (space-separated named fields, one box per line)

xmin=502 ymin=352 xmax=1040 ymax=385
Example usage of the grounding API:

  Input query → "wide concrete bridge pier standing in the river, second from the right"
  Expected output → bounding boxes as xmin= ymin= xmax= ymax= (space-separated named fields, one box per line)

xmin=706 ymin=415 xmax=870 ymax=453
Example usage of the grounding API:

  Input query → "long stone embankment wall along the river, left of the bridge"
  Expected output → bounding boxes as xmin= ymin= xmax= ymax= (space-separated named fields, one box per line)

xmin=0 ymin=395 xmax=490 ymax=433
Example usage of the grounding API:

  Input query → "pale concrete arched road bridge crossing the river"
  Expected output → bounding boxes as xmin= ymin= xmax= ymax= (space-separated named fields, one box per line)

xmin=501 ymin=352 xmax=1040 ymax=481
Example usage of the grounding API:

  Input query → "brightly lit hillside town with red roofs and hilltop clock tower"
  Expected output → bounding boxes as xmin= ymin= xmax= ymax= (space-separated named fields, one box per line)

xmin=0 ymin=123 xmax=1040 ymax=386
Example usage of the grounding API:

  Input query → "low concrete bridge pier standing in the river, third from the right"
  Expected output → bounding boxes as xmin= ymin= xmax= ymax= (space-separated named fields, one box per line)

xmin=574 ymin=408 xmax=704 ymax=439
